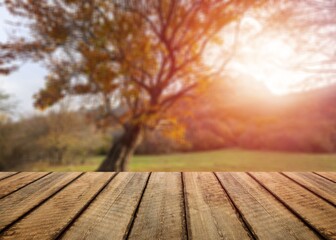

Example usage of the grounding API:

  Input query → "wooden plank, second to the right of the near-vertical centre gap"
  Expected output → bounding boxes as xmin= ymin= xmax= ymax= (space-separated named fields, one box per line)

xmin=216 ymin=173 xmax=320 ymax=239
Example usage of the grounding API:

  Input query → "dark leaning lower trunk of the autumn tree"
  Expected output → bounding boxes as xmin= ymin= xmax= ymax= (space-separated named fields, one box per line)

xmin=97 ymin=125 xmax=142 ymax=172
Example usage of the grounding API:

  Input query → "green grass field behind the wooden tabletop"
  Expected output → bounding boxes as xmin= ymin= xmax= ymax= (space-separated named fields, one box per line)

xmin=29 ymin=150 xmax=336 ymax=171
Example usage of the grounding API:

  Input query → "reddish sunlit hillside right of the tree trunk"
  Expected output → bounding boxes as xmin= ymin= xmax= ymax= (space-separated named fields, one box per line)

xmin=140 ymin=81 xmax=336 ymax=152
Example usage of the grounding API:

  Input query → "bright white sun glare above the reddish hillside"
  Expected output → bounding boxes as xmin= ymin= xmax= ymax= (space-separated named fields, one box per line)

xmin=204 ymin=15 xmax=306 ymax=95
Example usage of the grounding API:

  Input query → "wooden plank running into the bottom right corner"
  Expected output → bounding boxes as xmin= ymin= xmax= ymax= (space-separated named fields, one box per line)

xmin=251 ymin=172 xmax=336 ymax=239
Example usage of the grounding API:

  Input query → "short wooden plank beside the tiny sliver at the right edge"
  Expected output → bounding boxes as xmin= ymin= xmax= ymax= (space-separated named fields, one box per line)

xmin=284 ymin=172 xmax=336 ymax=204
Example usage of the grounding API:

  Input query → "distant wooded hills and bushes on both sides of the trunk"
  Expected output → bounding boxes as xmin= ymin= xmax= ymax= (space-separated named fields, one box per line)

xmin=0 ymin=78 xmax=336 ymax=170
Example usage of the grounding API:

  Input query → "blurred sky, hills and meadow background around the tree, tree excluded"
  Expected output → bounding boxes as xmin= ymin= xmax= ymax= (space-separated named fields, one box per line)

xmin=0 ymin=0 xmax=336 ymax=171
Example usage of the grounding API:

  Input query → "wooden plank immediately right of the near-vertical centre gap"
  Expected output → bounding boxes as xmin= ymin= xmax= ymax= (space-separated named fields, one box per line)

xmin=183 ymin=172 xmax=250 ymax=239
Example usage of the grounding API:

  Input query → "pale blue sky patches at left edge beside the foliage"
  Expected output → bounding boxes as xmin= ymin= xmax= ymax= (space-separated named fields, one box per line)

xmin=0 ymin=6 xmax=46 ymax=114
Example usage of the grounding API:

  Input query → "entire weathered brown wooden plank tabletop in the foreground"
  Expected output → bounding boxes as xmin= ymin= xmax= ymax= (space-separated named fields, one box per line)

xmin=0 ymin=172 xmax=336 ymax=240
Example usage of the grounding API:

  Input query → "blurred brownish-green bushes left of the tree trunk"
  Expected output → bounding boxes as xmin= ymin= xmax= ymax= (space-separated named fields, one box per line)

xmin=0 ymin=111 xmax=111 ymax=170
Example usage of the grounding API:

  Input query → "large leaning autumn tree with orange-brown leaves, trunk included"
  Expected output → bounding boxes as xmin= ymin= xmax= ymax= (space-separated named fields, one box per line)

xmin=0 ymin=0 xmax=261 ymax=171
